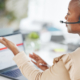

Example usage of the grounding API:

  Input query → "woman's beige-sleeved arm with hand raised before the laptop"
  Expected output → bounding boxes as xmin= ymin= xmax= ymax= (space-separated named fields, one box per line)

xmin=0 ymin=38 xmax=70 ymax=80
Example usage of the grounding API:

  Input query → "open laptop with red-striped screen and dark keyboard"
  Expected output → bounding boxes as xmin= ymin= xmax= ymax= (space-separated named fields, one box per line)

xmin=0 ymin=33 xmax=27 ymax=80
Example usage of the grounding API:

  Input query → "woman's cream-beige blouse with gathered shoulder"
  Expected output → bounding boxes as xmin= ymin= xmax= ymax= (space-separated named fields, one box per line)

xmin=13 ymin=48 xmax=80 ymax=80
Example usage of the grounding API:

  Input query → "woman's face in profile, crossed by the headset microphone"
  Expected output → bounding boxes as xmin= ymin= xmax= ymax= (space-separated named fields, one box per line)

xmin=65 ymin=0 xmax=80 ymax=33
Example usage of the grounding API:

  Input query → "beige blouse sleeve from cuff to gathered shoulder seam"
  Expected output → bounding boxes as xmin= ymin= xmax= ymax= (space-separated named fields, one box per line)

xmin=13 ymin=52 xmax=71 ymax=80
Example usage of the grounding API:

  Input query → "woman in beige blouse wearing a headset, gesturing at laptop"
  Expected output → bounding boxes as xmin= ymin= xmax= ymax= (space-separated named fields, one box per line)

xmin=0 ymin=0 xmax=80 ymax=80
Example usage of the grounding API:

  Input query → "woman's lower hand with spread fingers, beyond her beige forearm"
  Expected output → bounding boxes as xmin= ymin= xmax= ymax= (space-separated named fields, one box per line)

xmin=29 ymin=53 xmax=49 ymax=71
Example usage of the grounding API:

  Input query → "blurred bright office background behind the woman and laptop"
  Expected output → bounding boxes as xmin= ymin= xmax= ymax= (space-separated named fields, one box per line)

xmin=0 ymin=0 xmax=80 ymax=65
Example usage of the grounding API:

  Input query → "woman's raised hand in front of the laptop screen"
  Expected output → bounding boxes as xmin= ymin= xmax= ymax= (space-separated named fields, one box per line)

xmin=0 ymin=37 xmax=19 ymax=55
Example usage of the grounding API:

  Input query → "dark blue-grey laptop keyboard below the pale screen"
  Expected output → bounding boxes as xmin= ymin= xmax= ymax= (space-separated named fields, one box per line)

xmin=2 ymin=69 xmax=22 ymax=78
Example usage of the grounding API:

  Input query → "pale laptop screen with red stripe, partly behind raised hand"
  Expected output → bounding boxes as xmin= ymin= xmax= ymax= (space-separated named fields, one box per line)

xmin=0 ymin=34 xmax=24 ymax=70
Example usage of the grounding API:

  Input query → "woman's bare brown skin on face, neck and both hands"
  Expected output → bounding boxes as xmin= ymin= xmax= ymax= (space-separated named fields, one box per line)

xmin=0 ymin=0 xmax=80 ymax=71
